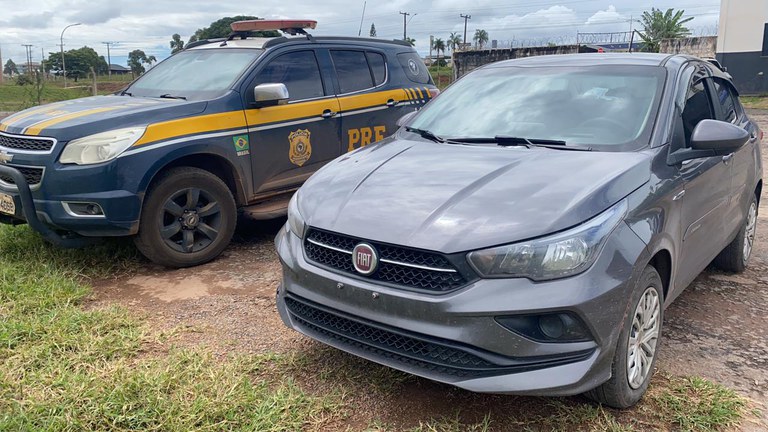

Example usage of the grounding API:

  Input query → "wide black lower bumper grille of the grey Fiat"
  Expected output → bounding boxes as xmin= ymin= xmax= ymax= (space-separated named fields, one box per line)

xmin=285 ymin=294 xmax=594 ymax=379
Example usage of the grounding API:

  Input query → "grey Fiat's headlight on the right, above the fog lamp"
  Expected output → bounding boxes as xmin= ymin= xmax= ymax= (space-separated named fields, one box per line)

xmin=468 ymin=200 xmax=627 ymax=281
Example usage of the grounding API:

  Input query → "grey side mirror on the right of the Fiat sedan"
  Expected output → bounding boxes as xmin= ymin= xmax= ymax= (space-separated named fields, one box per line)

xmin=667 ymin=120 xmax=749 ymax=165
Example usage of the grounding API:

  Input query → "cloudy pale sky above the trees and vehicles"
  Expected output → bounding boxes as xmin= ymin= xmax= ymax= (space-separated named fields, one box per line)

xmin=0 ymin=0 xmax=720 ymax=65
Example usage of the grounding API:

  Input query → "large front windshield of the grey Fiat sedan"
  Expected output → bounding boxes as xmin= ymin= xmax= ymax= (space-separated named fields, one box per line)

xmin=409 ymin=66 xmax=665 ymax=150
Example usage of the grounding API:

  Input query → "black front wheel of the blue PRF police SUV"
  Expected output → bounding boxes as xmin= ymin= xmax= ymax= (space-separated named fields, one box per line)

xmin=134 ymin=167 xmax=237 ymax=268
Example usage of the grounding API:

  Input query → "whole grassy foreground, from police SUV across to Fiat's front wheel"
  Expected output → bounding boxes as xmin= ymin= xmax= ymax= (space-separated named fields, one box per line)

xmin=0 ymin=226 xmax=751 ymax=432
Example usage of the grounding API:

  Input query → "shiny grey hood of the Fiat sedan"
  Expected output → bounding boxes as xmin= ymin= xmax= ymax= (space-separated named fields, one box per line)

xmin=299 ymin=138 xmax=650 ymax=253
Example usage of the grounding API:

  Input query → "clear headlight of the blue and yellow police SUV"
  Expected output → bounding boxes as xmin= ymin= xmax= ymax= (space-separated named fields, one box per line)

xmin=59 ymin=127 xmax=147 ymax=165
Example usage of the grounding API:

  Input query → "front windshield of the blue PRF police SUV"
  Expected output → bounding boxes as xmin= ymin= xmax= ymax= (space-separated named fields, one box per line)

xmin=125 ymin=48 xmax=264 ymax=100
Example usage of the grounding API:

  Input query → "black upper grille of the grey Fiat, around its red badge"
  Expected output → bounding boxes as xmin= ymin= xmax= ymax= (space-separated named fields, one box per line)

xmin=304 ymin=228 xmax=468 ymax=292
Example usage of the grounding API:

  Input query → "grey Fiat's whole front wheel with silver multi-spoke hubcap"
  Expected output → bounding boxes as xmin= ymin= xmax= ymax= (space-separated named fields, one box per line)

xmin=585 ymin=265 xmax=664 ymax=409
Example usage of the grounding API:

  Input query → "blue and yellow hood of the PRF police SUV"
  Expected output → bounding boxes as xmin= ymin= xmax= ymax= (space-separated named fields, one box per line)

xmin=0 ymin=95 xmax=206 ymax=141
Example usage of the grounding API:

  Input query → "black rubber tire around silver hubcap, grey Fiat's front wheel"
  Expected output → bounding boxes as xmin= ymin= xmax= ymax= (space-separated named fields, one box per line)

xmin=584 ymin=265 xmax=664 ymax=409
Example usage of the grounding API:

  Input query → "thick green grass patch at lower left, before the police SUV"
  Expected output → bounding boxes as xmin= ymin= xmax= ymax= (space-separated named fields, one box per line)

xmin=0 ymin=226 xmax=343 ymax=431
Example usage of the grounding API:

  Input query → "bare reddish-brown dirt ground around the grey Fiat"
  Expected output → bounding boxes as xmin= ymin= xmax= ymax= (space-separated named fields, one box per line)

xmin=84 ymin=111 xmax=768 ymax=430
